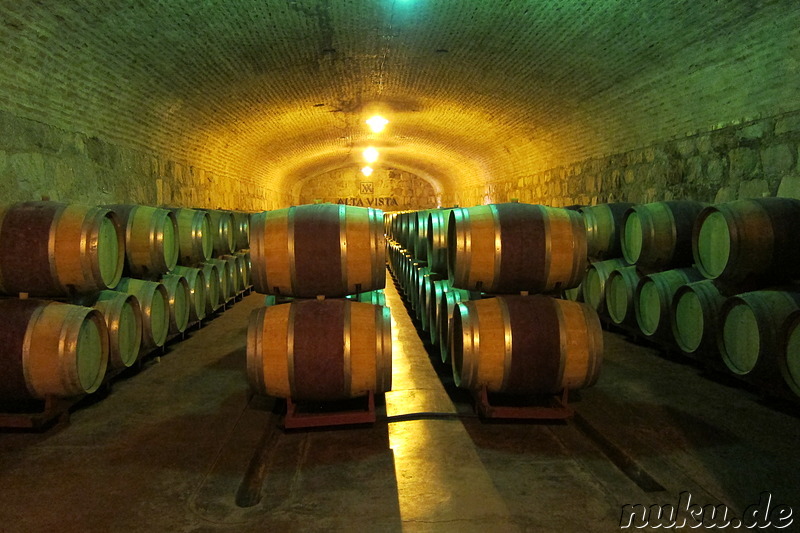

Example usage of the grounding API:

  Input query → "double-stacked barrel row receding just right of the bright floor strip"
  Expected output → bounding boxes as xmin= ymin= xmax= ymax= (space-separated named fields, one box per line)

xmin=387 ymin=202 xmax=603 ymax=395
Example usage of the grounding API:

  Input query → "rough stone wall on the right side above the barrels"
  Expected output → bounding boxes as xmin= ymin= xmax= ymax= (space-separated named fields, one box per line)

xmin=443 ymin=108 xmax=800 ymax=206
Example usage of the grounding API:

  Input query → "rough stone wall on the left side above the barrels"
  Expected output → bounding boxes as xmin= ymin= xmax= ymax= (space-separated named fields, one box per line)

xmin=0 ymin=111 xmax=290 ymax=211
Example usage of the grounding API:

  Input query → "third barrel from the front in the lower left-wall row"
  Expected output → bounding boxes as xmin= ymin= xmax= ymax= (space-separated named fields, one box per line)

xmin=115 ymin=278 xmax=169 ymax=353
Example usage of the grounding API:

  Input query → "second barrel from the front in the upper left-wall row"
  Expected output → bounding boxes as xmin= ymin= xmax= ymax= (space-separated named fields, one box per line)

xmin=106 ymin=204 xmax=178 ymax=279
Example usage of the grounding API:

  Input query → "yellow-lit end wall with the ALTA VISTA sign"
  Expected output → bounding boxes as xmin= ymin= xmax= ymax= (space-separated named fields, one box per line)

xmin=296 ymin=167 xmax=441 ymax=211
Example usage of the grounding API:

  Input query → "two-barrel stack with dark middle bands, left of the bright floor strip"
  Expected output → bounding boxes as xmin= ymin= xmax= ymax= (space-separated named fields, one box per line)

xmin=247 ymin=204 xmax=392 ymax=402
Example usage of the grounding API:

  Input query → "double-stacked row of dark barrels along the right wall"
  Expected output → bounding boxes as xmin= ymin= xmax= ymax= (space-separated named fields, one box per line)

xmin=568 ymin=198 xmax=800 ymax=397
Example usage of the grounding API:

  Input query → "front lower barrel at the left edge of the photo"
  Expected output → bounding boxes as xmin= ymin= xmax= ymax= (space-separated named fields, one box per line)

xmin=0 ymin=298 xmax=108 ymax=400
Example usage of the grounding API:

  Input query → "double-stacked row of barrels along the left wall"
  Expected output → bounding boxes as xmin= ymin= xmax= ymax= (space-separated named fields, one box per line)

xmin=0 ymin=201 xmax=249 ymax=401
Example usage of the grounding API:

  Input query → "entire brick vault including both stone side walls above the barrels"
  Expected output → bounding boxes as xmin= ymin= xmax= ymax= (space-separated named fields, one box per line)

xmin=0 ymin=0 xmax=800 ymax=210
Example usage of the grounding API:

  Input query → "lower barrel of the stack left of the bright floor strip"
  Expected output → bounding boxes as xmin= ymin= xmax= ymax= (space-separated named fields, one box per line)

xmin=247 ymin=300 xmax=392 ymax=401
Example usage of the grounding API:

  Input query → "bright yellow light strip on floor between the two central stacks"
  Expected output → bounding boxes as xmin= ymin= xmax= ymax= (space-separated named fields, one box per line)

xmin=386 ymin=278 xmax=516 ymax=531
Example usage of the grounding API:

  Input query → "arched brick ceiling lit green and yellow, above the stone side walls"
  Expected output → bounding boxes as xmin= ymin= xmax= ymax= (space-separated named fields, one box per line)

xmin=0 ymin=0 xmax=798 ymax=201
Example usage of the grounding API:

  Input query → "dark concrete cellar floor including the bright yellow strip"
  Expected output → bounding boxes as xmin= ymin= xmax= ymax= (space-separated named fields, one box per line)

xmin=0 ymin=274 xmax=800 ymax=533
